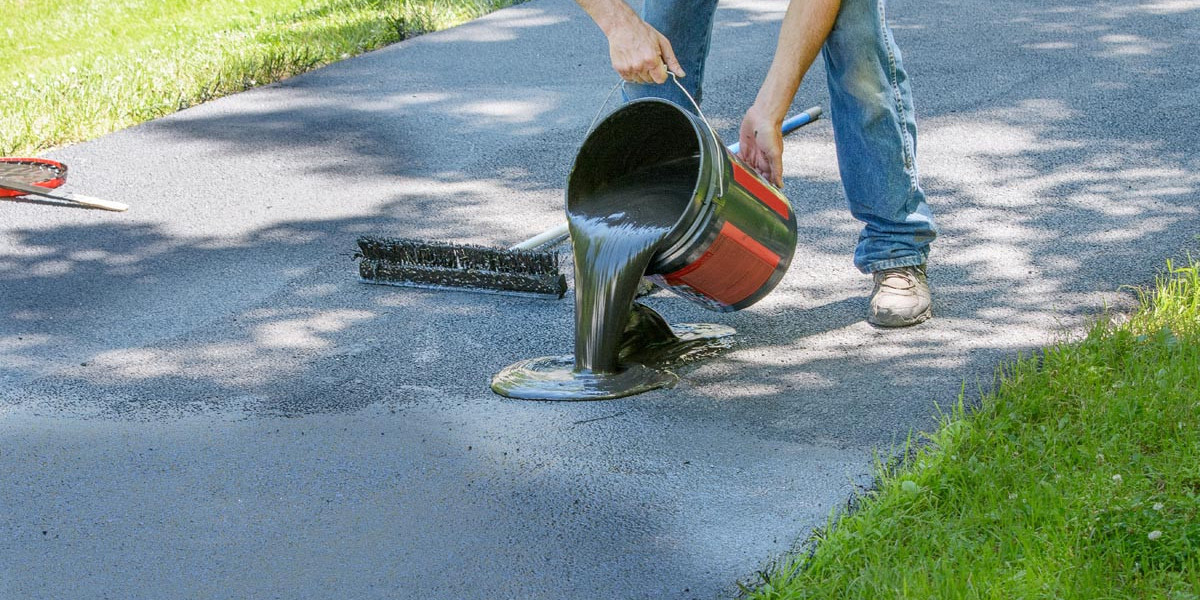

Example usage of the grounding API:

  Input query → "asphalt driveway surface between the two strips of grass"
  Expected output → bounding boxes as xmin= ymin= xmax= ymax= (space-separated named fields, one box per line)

xmin=0 ymin=0 xmax=1200 ymax=600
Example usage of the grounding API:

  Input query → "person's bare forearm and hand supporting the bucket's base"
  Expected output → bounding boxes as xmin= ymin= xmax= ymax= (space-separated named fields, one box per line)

xmin=738 ymin=0 xmax=841 ymax=187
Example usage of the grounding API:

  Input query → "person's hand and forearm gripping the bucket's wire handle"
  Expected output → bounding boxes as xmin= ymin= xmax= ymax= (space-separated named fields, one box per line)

xmin=575 ymin=0 xmax=684 ymax=83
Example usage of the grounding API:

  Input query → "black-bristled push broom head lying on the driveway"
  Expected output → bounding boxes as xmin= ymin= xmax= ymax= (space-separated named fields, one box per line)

xmin=355 ymin=236 xmax=566 ymax=298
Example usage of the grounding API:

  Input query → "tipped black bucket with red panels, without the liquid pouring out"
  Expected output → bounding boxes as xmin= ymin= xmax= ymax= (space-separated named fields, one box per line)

xmin=566 ymin=98 xmax=796 ymax=312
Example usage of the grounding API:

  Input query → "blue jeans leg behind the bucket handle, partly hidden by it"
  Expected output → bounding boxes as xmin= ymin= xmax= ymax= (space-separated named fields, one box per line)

xmin=625 ymin=0 xmax=716 ymax=112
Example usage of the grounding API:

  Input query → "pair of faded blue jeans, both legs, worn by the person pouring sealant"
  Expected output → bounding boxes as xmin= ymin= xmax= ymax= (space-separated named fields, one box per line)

xmin=625 ymin=0 xmax=937 ymax=272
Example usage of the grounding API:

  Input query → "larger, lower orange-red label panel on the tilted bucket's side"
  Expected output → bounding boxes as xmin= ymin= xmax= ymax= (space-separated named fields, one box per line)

xmin=665 ymin=222 xmax=780 ymax=306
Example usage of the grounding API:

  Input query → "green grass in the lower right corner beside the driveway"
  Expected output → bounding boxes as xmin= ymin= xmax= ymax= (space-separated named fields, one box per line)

xmin=746 ymin=263 xmax=1200 ymax=600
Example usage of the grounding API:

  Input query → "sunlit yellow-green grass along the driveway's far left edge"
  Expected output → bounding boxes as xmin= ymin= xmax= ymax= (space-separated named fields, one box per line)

xmin=0 ymin=0 xmax=520 ymax=156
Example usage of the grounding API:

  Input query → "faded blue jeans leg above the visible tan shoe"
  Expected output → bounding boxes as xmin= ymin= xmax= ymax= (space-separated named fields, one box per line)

xmin=822 ymin=0 xmax=937 ymax=272
